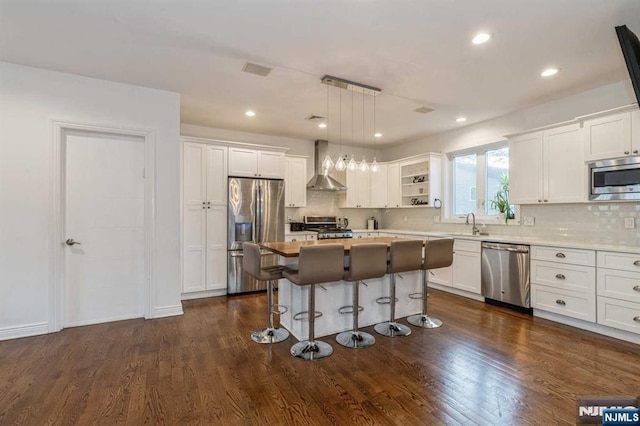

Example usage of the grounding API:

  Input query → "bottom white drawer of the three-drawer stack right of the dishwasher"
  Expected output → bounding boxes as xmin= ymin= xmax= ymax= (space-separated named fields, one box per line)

xmin=531 ymin=284 xmax=596 ymax=322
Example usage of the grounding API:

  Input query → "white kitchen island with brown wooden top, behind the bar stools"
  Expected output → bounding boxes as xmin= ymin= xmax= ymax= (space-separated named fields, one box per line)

xmin=260 ymin=237 xmax=422 ymax=340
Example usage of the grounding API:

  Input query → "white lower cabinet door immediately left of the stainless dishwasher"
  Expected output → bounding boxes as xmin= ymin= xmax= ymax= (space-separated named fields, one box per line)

xmin=451 ymin=238 xmax=481 ymax=294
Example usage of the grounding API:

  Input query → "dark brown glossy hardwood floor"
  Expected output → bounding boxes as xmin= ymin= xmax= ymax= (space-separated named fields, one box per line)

xmin=0 ymin=290 xmax=640 ymax=425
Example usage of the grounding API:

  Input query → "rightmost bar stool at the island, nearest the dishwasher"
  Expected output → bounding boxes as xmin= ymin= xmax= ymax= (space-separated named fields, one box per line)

xmin=407 ymin=239 xmax=453 ymax=328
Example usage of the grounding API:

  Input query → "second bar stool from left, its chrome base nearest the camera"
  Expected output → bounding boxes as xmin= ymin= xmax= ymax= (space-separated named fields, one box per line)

xmin=283 ymin=244 xmax=344 ymax=361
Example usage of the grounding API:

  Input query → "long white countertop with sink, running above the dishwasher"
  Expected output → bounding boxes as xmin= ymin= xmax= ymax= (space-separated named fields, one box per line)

xmin=353 ymin=229 xmax=640 ymax=254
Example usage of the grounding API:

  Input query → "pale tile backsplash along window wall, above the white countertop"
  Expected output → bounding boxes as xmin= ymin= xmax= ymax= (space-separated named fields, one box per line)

xmin=382 ymin=202 xmax=640 ymax=246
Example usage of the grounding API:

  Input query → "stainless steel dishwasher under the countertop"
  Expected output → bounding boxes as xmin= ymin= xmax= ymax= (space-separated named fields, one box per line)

xmin=480 ymin=242 xmax=531 ymax=308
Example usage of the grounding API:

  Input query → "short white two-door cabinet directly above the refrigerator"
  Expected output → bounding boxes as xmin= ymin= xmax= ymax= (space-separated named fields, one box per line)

xmin=229 ymin=148 xmax=285 ymax=179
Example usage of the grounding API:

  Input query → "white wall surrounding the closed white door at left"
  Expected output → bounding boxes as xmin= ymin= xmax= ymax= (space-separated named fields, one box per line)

xmin=0 ymin=62 xmax=182 ymax=339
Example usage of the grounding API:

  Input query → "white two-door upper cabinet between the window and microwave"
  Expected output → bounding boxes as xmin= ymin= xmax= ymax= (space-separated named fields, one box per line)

xmin=509 ymin=124 xmax=587 ymax=204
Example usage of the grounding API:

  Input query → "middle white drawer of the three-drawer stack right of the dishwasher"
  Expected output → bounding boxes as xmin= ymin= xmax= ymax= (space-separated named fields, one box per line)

xmin=531 ymin=260 xmax=596 ymax=294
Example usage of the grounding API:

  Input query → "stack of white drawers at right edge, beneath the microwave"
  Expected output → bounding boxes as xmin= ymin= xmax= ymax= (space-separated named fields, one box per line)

xmin=597 ymin=251 xmax=640 ymax=333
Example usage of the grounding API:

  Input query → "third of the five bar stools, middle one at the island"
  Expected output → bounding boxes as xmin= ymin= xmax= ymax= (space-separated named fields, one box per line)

xmin=336 ymin=243 xmax=387 ymax=348
